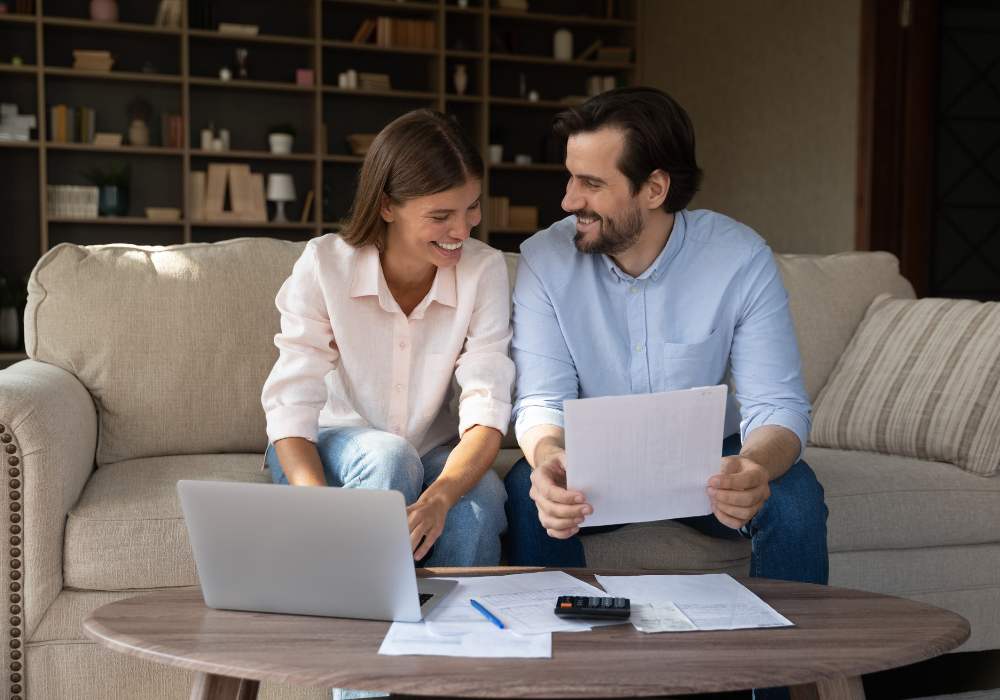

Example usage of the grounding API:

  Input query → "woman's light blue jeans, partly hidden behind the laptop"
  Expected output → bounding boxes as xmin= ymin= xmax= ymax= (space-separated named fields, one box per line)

xmin=265 ymin=428 xmax=507 ymax=566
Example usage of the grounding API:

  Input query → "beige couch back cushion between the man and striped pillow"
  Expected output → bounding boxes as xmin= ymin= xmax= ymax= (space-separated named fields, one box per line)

xmin=775 ymin=252 xmax=913 ymax=401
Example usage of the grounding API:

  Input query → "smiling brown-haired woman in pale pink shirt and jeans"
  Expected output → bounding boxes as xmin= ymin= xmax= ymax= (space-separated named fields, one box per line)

xmin=262 ymin=110 xmax=514 ymax=566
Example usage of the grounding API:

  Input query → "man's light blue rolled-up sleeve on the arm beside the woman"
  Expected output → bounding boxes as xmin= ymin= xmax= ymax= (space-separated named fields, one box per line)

xmin=511 ymin=255 xmax=580 ymax=442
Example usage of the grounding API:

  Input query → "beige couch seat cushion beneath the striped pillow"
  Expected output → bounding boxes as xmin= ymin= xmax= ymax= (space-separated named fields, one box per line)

xmin=805 ymin=447 xmax=1000 ymax=552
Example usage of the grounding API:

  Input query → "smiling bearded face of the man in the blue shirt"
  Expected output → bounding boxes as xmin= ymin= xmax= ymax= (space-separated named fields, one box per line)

xmin=562 ymin=128 xmax=646 ymax=255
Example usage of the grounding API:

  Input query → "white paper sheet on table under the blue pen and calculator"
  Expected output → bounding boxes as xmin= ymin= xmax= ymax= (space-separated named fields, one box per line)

xmin=425 ymin=571 xmax=622 ymax=636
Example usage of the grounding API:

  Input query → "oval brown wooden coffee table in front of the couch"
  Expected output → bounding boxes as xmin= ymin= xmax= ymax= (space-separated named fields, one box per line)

xmin=83 ymin=568 xmax=969 ymax=700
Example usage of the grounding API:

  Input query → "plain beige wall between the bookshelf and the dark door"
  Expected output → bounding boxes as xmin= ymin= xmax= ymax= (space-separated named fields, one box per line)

xmin=640 ymin=0 xmax=862 ymax=253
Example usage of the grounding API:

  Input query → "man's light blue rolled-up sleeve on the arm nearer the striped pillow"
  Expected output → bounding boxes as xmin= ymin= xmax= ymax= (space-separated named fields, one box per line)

xmin=730 ymin=246 xmax=812 ymax=458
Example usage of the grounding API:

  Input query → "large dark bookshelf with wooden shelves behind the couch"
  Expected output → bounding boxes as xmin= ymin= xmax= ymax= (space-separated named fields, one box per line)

xmin=0 ymin=0 xmax=641 ymax=356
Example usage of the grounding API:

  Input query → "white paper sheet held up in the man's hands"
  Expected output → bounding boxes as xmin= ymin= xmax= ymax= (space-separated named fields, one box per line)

xmin=563 ymin=384 xmax=727 ymax=527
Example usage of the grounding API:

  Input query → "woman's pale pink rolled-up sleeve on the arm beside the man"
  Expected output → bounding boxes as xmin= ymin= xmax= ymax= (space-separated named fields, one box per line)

xmin=455 ymin=253 xmax=514 ymax=435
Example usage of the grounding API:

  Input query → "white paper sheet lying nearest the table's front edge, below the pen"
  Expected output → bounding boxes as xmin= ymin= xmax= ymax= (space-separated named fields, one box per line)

xmin=378 ymin=622 xmax=552 ymax=659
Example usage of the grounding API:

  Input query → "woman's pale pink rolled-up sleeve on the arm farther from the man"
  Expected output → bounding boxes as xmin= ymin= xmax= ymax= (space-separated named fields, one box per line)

xmin=261 ymin=243 xmax=340 ymax=443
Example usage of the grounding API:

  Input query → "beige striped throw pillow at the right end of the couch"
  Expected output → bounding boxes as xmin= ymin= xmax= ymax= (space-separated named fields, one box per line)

xmin=811 ymin=294 xmax=1000 ymax=476
